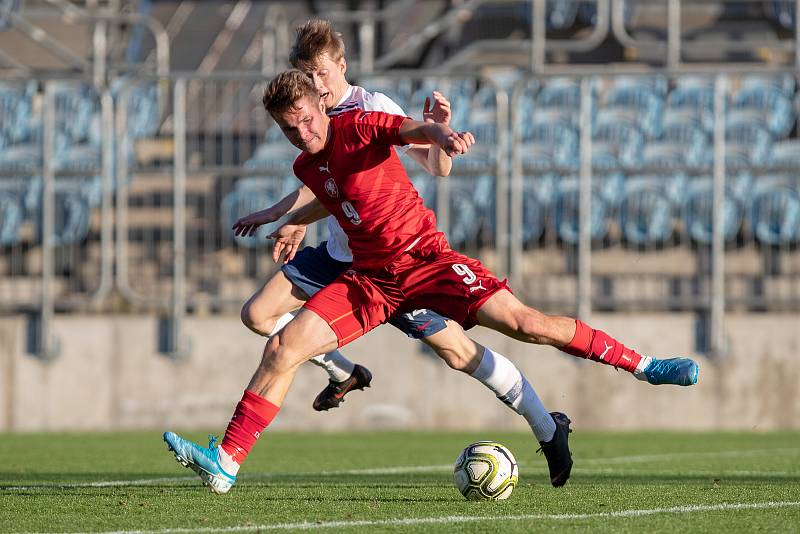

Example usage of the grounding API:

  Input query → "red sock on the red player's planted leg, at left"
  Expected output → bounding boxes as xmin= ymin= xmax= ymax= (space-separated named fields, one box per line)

xmin=220 ymin=390 xmax=280 ymax=465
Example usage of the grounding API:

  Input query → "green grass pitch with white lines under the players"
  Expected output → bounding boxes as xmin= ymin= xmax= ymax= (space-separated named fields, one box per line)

xmin=0 ymin=428 xmax=800 ymax=533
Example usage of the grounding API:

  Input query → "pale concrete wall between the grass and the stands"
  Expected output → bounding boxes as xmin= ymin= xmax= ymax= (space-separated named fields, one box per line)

xmin=0 ymin=314 xmax=800 ymax=432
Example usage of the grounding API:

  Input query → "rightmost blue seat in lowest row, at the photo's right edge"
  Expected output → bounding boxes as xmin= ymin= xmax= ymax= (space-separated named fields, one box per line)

xmin=750 ymin=176 xmax=800 ymax=246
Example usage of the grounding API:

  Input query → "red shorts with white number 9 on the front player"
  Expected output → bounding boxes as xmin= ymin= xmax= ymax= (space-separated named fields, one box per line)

xmin=303 ymin=233 xmax=508 ymax=347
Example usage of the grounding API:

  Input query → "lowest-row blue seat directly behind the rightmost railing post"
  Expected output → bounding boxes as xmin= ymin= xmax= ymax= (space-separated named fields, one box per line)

xmin=683 ymin=177 xmax=744 ymax=245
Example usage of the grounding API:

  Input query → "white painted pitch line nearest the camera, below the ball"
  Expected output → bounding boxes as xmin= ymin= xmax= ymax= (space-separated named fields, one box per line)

xmin=18 ymin=501 xmax=800 ymax=534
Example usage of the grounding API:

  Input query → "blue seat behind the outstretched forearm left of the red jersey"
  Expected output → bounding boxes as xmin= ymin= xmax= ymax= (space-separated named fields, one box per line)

xmin=220 ymin=176 xmax=293 ymax=248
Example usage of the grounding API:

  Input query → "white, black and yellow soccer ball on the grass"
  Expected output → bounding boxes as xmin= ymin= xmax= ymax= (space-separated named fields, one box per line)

xmin=453 ymin=441 xmax=519 ymax=501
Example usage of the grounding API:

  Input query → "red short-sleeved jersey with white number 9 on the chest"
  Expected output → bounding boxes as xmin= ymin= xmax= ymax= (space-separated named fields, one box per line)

xmin=294 ymin=110 xmax=436 ymax=271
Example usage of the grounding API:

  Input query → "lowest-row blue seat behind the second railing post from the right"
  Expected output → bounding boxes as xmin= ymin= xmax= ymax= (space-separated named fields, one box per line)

xmin=554 ymin=178 xmax=610 ymax=245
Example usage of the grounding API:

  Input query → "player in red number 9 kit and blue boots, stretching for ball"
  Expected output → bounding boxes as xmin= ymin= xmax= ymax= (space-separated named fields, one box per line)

xmin=164 ymin=70 xmax=697 ymax=493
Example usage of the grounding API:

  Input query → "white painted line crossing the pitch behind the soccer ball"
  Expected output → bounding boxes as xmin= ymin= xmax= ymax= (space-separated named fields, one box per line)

xmin=0 ymin=448 xmax=800 ymax=491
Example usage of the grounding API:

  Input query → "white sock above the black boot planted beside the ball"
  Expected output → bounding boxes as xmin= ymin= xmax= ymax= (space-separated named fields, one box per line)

xmin=472 ymin=347 xmax=556 ymax=441
